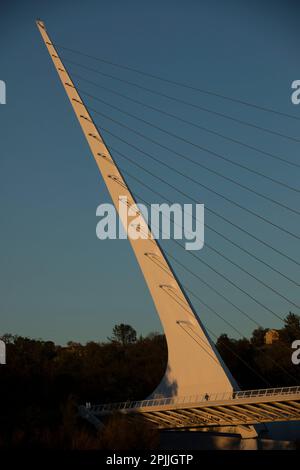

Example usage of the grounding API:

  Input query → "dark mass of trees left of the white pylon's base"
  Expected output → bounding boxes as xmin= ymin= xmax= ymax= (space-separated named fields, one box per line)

xmin=0 ymin=328 xmax=167 ymax=449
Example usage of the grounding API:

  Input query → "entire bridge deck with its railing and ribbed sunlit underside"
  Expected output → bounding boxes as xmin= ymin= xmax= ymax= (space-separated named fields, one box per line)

xmin=88 ymin=387 xmax=300 ymax=429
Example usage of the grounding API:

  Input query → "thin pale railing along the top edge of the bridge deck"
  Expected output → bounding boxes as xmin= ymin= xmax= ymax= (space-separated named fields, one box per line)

xmin=89 ymin=386 xmax=300 ymax=413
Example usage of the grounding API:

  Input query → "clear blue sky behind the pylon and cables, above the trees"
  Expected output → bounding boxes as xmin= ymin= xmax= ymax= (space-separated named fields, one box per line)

xmin=0 ymin=0 xmax=300 ymax=343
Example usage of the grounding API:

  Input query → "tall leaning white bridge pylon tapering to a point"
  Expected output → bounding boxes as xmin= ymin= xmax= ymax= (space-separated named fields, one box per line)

xmin=37 ymin=20 xmax=237 ymax=397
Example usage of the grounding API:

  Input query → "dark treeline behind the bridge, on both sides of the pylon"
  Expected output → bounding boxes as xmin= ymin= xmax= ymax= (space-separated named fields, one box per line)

xmin=0 ymin=313 xmax=300 ymax=448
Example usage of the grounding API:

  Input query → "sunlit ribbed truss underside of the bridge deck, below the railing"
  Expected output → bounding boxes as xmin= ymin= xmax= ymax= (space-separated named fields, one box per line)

xmin=87 ymin=387 xmax=300 ymax=437
